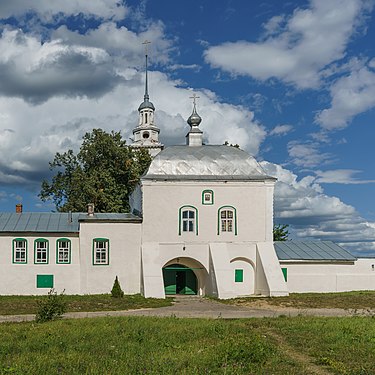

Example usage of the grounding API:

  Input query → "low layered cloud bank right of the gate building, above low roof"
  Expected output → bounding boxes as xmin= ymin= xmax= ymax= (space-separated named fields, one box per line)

xmin=261 ymin=161 xmax=375 ymax=256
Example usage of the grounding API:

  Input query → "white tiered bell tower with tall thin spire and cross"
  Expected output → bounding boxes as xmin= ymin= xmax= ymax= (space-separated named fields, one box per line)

xmin=131 ymin=40 xmax=164 ymax=157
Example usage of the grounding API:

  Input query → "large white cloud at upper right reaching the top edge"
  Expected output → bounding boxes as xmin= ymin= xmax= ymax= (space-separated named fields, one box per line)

xmin=204 ymin=0 xmax=370 ymax=89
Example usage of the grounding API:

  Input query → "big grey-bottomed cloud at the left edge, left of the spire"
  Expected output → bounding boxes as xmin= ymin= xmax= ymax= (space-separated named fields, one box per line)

xmin=0 ymin=30 xmax=125 ymax=104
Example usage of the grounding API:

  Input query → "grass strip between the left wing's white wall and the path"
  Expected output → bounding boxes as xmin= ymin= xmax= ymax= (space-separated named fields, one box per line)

xmin=0 ymin=294 xmax=172 ymax=315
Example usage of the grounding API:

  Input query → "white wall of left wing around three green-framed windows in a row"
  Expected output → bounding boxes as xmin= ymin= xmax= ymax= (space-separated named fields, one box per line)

xmin=0 ymin=233 xmax=80 ymax=295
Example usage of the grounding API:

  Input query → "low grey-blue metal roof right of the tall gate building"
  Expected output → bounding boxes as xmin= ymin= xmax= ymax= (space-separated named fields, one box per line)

xmin=274 ymin=241 xmax=357 ymax=261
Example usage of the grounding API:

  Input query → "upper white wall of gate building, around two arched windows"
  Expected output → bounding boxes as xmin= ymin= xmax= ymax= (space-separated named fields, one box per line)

xmin=142 ymin=181 xmax=273 ymax=242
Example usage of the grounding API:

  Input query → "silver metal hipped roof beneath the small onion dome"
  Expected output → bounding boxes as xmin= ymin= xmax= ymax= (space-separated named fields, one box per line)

xmin=142 ymin=145 xmax=276 ymax=181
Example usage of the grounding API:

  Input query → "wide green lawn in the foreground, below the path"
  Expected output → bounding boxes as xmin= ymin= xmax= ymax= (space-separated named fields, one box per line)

xmin=0 ymin=317 xmax=375 ymax=374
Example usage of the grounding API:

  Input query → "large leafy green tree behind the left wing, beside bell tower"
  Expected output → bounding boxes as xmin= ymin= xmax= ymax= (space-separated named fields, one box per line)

xmin=39 ymin=129 xmax=151 ymax=212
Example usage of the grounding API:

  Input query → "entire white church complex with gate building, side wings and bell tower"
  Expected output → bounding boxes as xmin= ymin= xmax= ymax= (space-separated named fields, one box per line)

xmin=0 ymin=57 xmax=375 ymax=299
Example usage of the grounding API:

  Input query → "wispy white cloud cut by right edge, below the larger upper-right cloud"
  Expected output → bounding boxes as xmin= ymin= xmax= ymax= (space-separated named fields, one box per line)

xmin=316 ymin=67 xmax=375 ymax=130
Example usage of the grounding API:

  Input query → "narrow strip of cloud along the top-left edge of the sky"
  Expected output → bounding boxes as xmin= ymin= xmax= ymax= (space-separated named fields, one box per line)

xmin=0 ymin=0 xmax=128 ymax=22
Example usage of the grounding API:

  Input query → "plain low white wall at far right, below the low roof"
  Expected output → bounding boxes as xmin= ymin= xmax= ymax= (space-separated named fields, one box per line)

xmin=280 ymin=259 xmax=375 ymax=293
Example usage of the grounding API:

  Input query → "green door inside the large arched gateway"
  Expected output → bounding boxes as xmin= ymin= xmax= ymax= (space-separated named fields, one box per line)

xmin=163 ymin=264 xmax=197 ymax=295
